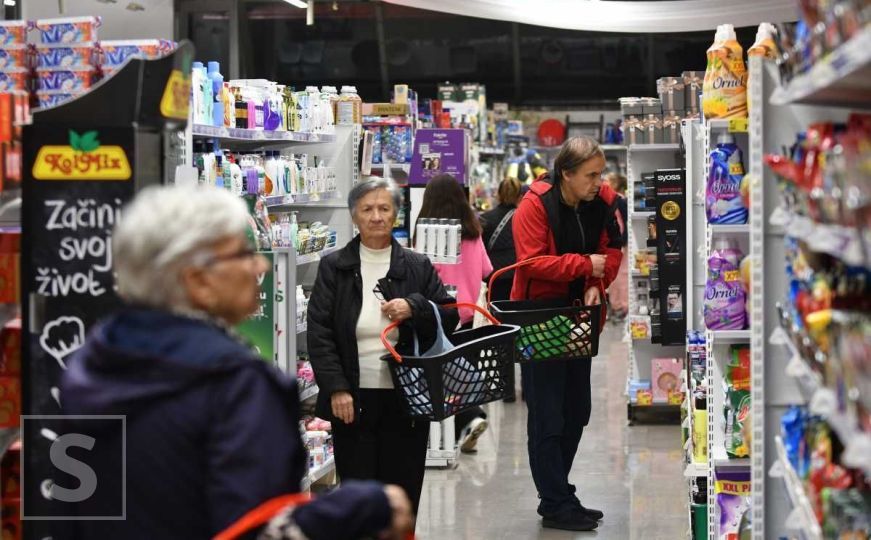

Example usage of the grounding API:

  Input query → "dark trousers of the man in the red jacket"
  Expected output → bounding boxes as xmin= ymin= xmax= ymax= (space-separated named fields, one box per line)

xmin=521 ymin=359 xmax=592 ymax=516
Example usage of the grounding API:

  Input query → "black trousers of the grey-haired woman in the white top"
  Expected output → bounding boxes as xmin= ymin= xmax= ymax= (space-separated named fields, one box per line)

xmin=333 ymin=389 xmax=429 ymax=514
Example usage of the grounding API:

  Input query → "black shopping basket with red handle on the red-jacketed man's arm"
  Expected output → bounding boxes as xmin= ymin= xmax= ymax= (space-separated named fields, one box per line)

xmin=487 ymin=255 xmax=605 ymax=362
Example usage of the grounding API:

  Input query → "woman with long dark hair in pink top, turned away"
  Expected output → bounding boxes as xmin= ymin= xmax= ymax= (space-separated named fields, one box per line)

xmin=418 ymin=174 xmax=493 ymax=453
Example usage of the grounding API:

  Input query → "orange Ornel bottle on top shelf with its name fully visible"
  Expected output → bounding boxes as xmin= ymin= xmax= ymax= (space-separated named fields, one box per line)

xmin=702 ymin=24 xmax=747 ymax=119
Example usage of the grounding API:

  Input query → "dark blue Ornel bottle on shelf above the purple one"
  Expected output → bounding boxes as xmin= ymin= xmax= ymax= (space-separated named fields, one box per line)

xmin=705 ymin=133 xmax=748 ymax=224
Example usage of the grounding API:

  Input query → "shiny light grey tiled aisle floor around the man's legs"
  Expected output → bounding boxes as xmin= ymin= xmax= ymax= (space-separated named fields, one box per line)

xmin=417 ymin=325 xmax=688 ymax=540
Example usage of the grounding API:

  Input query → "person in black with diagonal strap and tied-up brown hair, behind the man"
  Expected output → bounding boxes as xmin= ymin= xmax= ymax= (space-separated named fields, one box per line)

xmin=481 ymin=177 xmax=522 ymax=403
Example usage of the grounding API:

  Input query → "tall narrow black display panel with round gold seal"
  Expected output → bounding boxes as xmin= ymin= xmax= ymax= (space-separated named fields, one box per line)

xmin=654 ymin=169 xmax=687 ymax=345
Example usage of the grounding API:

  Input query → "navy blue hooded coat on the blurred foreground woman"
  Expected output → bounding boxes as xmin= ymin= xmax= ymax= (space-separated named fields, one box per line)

xmin=55 ymin=309 xmax=390 ymax=539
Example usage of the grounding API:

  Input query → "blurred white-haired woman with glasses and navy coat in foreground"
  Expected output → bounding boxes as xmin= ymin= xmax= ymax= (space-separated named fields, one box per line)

xmin=55 ymin=187 xmax=413 ymax=540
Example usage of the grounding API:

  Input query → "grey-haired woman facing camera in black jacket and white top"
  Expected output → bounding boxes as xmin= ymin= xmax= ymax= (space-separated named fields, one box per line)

xmin=308 ymin=179 xmax=457 ymax=512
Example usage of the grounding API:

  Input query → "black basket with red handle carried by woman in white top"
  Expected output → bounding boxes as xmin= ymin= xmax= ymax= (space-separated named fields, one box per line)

xmin=381 ymin=304 xmax=520 ymax=422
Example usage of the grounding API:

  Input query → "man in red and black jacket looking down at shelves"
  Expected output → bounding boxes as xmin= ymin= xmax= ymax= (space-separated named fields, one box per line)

xmin=511 ymin=137 xmax=622 ymax=531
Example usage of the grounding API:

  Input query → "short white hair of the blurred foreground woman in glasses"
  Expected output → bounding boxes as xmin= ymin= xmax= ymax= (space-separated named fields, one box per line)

xmin=112 ymin=186 xmax=250 ymax=309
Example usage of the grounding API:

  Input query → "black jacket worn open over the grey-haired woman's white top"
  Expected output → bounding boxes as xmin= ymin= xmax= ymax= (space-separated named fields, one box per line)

xmin=308 ymin=236 xmax=459 ymax=421
